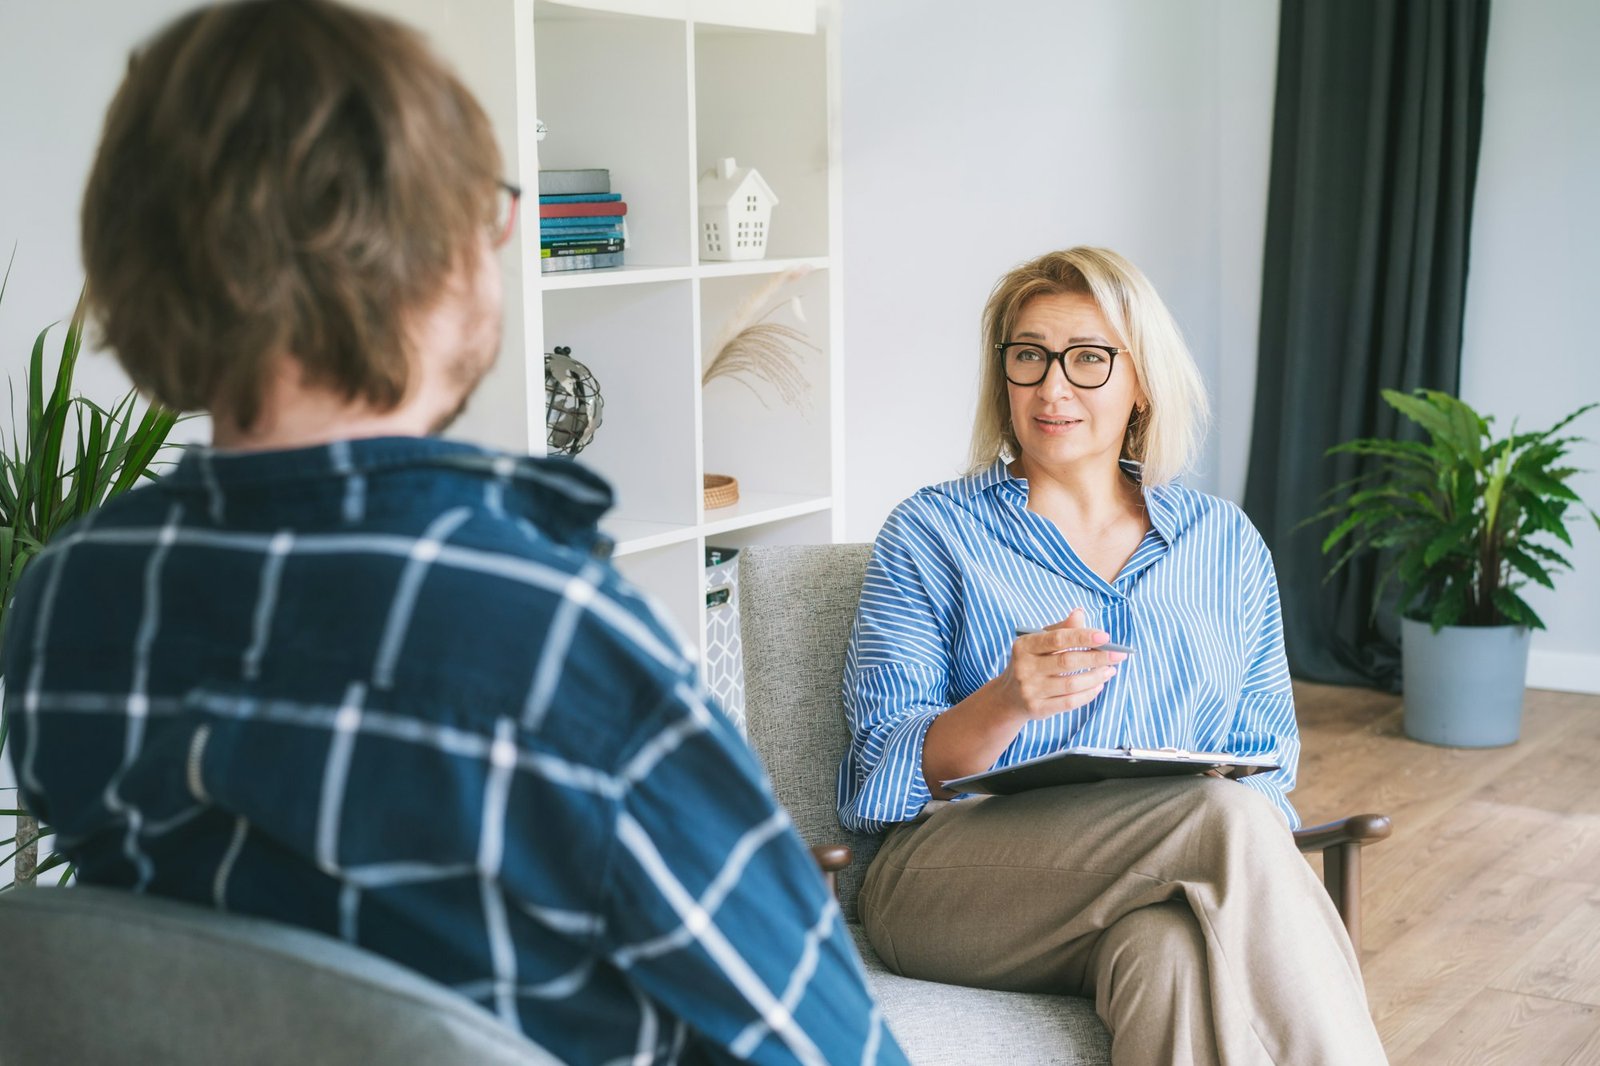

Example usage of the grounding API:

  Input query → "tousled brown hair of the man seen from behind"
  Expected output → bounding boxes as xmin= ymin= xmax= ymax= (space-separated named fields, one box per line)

xmin=83 ymin=0 xmax=501 ymax=427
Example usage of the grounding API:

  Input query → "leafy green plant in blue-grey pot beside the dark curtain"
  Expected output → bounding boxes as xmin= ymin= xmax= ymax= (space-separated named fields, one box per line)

xmin=1312 ymin=389 xmax=1600 ymax=747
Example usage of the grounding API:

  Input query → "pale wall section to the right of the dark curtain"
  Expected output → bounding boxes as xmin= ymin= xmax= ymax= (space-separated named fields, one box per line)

xmin=1461 ymin=0 xmax=1600 ymax=693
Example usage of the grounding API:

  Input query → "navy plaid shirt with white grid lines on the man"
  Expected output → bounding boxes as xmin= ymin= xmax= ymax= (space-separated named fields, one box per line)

xmin=5 ymin=439 xmax=904 ymax=1064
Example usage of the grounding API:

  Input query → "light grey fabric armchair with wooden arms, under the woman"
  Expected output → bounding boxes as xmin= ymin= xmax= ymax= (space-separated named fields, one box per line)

xmin=739 ymin=544 xmax=1389 ymax=1066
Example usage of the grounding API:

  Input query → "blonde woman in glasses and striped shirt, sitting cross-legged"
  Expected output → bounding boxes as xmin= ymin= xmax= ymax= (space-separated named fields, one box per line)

xmin=840 ymin=248 xmax=1384 ymax=1066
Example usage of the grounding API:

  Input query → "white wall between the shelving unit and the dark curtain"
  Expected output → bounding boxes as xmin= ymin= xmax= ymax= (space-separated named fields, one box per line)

xmin=843 ymin=0 xmax=1277 ymax=539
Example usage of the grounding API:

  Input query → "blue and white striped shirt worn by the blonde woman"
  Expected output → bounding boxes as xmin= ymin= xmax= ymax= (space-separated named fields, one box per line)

xmin=838 ymin=461 xmax=1299 ymax=832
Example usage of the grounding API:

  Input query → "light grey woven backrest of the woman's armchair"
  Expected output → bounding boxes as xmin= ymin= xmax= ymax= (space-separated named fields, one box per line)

xmin=739 ymin=544 xmax=878 ymax=920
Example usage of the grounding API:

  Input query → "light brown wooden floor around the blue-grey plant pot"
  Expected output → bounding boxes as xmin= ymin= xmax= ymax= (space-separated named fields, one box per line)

xmin=1294 ymin=685 xmax=1600 ymax=1066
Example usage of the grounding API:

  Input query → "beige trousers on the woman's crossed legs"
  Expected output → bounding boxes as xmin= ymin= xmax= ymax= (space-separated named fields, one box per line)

xmin=861 ymin=778 xmax=1387 ymax=1066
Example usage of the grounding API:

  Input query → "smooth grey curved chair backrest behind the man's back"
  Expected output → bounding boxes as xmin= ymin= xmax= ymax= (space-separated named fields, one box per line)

xmin=0 ymin=887 xmax=557 ymax=1066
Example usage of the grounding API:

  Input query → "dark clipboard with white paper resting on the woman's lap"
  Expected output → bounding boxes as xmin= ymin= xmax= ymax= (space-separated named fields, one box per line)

xmin=944 ymin=747 xmax=1278 ymax=795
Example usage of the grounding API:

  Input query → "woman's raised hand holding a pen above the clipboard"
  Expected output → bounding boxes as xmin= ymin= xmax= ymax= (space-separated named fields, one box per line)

xmin=995 ymin=607 xmax=1128 ymax=719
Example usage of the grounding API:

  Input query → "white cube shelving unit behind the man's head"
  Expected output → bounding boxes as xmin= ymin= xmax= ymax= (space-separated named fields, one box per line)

xmin=366 ymin=0 xmax=843 ymax=659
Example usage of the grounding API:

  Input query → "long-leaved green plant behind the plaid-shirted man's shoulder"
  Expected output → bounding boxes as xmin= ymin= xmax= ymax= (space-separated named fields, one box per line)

xmin=0 ymin=264 xmax=178 ymax=892
